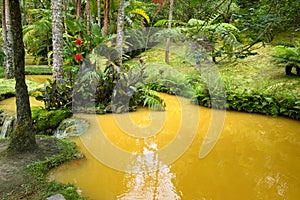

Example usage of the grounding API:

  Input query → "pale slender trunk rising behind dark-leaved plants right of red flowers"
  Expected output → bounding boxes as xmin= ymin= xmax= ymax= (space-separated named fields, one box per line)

xmin=116 ymin=0 xmax=124 ymax=69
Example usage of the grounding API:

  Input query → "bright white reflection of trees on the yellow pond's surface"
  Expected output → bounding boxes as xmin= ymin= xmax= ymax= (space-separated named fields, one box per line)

xmin=118 ymin=140 xmax=181 ymax=200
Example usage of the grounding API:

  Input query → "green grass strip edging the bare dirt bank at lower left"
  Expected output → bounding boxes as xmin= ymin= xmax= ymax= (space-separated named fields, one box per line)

xmin=0 ymin=136 xmax=85 ymax=200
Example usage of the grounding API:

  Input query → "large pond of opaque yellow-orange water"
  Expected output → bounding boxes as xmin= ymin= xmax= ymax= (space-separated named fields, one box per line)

xmin=48 ymin=94 xmax=300 ymax=200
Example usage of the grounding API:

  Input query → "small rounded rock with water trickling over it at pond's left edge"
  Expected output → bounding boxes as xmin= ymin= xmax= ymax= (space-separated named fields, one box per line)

xmin=54 ymin=118 xmax=89 ymax=138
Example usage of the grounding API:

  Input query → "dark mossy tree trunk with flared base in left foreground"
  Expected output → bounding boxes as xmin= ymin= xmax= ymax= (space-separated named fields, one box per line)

xmin=8 ymin=0 xmax=37 ymax=153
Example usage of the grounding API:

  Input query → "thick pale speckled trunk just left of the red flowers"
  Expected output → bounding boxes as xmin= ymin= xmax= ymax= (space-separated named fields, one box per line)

xmin=52 ymin=0 xmax=63 ymax=80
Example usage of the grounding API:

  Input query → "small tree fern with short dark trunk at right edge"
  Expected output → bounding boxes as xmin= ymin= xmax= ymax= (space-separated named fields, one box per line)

xmin=272 ymin=46 xmax=300 ymax=76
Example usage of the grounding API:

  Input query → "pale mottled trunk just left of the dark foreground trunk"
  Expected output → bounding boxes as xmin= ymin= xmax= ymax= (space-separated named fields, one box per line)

xmin=2 ymin=0 xmax=14 ymax=79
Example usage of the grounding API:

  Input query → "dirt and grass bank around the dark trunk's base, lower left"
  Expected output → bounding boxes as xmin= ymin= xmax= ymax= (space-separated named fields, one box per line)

xmin=0 ymin=136 xmax=84 ymax=200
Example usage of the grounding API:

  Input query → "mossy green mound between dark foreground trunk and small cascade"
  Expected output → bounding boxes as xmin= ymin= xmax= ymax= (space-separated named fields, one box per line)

xmin=31 ymin=107 xmax=72 ymax=135
